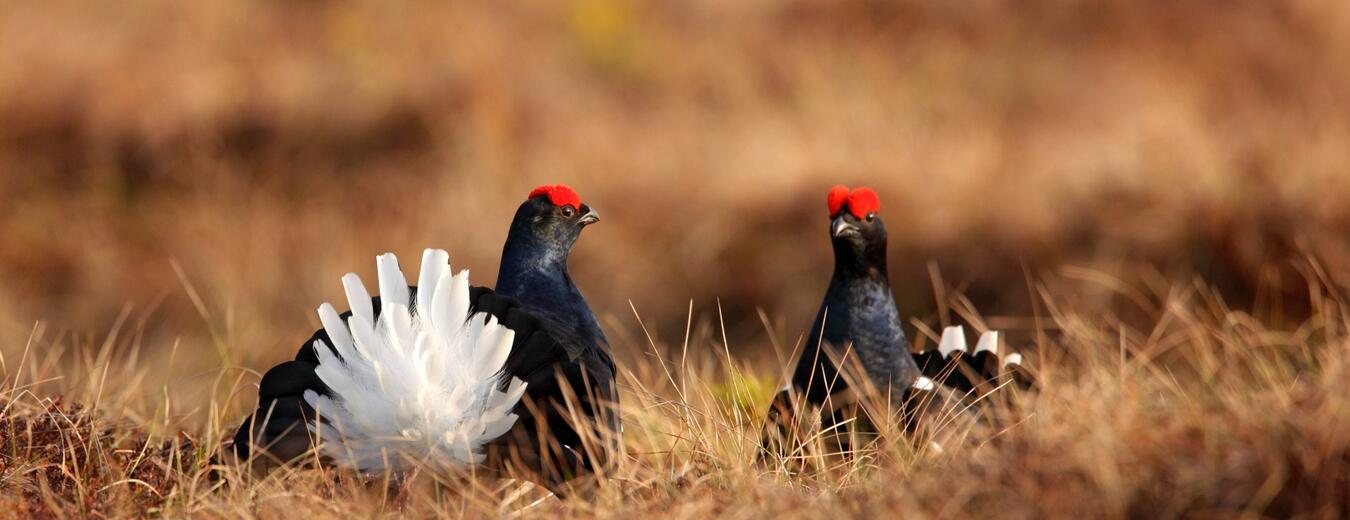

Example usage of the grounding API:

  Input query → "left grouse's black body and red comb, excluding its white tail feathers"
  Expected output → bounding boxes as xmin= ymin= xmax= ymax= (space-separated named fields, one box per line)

xmin=234 ymin=185 xmax=620 ymax=488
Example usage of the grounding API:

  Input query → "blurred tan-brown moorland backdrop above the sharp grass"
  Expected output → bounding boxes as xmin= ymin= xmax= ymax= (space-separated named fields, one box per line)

xmin=0 ymin=0 xmax=1350 ymax=369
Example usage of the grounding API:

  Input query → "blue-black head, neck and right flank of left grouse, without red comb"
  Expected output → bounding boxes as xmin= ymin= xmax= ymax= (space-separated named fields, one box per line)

xmin=495 ymin=197 xmax=621 ymax=479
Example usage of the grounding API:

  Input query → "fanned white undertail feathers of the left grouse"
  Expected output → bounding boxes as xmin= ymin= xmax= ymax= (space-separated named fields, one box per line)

xmin=305 ymin=250 xmax=525 ymax=471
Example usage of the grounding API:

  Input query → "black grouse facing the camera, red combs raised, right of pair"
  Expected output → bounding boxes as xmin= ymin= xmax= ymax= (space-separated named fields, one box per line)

xmin=768 ymin=186 xmax=1019 ymax=451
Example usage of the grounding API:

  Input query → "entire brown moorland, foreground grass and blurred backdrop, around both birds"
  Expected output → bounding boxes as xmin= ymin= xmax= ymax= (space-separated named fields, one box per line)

xmin=0 ymin=0 xmax=1350 ymax=519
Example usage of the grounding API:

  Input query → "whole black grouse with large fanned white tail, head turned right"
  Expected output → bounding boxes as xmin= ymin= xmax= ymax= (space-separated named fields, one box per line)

xmin=234 ymin=185 xmax=620 ymax=488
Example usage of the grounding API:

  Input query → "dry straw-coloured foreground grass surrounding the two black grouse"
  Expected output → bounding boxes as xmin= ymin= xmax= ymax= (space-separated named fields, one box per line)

xmin=0 ymin=262 xmax=1350 ymax=517
